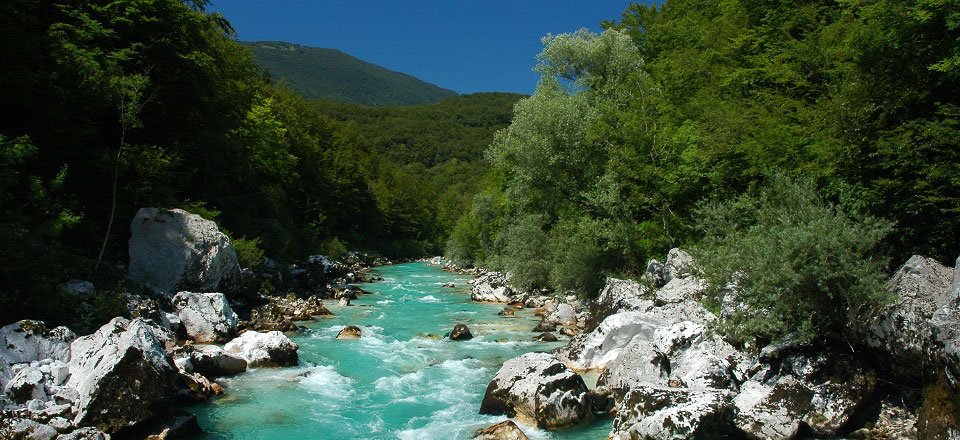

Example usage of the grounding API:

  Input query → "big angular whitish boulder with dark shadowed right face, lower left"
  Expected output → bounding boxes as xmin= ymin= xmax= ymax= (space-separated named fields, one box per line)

xmin=67 ymin=318 xmax=177 ymax=432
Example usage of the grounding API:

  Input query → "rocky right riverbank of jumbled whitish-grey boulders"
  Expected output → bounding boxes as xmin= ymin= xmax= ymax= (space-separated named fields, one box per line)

xmin=433 ymin=249 xmax=960 ymax=439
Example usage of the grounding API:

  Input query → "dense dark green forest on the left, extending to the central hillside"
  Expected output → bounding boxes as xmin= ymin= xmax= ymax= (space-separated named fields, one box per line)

xmin=0 ymin=0 xmax=518 ymax=328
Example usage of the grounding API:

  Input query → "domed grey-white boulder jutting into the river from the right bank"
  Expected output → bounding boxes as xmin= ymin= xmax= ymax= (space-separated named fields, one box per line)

xmin=480 ymin=353 xmax=592 ymax=429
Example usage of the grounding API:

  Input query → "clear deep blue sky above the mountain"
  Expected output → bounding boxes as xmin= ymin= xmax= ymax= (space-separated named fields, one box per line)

xmin=208 ymin=0 xmax=630 ymax=94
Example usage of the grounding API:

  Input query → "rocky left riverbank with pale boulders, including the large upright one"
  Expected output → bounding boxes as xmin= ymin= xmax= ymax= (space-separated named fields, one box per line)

xmin=0 ymin=208 xmax=389 ymax=440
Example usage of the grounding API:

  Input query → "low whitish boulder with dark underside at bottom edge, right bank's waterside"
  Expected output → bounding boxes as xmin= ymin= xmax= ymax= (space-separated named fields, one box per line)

xmin=610 ymin=385 xmax=735 ymax=440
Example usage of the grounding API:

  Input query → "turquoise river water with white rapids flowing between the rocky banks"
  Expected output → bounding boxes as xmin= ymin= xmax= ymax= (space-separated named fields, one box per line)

xmin=188 ymin=263 xmax=610 ymax=440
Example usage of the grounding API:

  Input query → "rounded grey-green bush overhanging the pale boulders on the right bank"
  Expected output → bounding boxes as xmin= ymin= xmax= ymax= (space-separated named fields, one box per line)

xmin=695 ymin=175 xmax=892 ymax=343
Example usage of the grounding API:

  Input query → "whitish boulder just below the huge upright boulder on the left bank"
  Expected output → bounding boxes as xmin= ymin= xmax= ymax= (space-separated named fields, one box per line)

xmin=173 ymin=292 xmax=239 ymax=343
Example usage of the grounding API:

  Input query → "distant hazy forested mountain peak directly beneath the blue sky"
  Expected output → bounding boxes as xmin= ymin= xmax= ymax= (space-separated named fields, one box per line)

xmin=243 ymin=41 xmax=456 ymax=105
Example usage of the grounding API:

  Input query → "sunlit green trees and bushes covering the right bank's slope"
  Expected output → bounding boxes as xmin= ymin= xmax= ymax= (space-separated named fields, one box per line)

xmin=447 ymin=0 xmax=960 ymax=317
